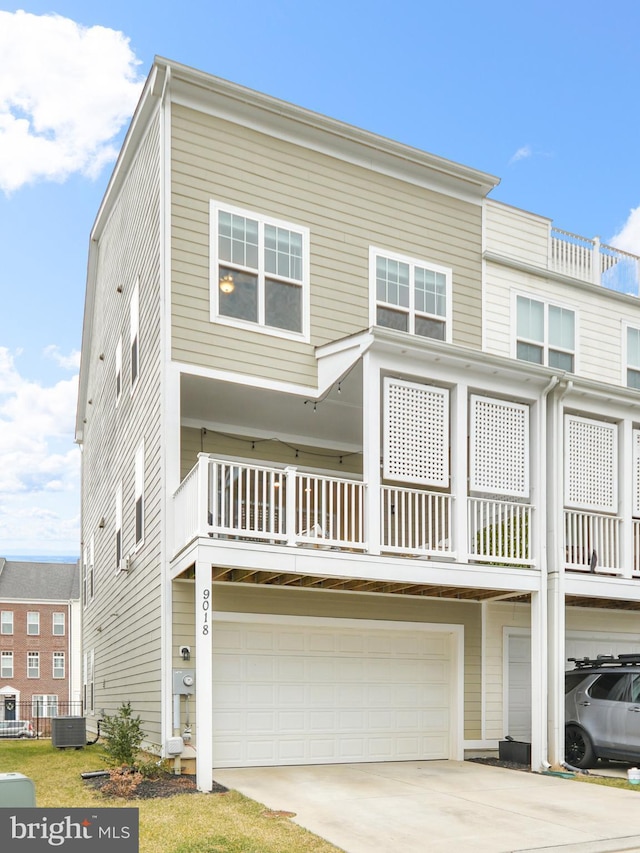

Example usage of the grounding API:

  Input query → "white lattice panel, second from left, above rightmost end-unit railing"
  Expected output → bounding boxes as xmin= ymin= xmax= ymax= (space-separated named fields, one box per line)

xmin=469 ymin=394 xmax=529 ymax=498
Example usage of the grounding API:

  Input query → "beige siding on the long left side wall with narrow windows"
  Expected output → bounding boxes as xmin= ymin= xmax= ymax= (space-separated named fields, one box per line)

xmin=82 ymin=115 xmax=162 ymax=744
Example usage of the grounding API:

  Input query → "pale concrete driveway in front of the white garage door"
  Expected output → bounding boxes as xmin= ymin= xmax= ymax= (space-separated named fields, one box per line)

xmin=214 ymin=761 xmax=640 ymax=853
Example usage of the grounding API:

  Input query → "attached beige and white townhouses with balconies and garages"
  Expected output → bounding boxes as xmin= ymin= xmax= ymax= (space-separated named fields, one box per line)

xmin=77 ymin=59 xmax=640 ymax=790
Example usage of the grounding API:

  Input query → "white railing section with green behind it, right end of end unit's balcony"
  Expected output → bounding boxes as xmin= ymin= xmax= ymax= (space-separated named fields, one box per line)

xmin=468 ymin=498 xmax=533 ymax=566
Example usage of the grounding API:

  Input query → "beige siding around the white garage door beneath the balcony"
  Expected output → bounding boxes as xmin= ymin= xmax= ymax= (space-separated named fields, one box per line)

xmin=173 ymin=581 xmax=481 ymax=740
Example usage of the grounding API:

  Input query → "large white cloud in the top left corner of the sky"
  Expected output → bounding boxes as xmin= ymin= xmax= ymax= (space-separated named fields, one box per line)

xmin=0 ymin=11 xmax=142 ymax=193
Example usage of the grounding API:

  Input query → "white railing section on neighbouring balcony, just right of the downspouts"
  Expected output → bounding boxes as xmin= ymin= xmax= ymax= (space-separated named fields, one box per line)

xmin=564 ymin=510 xmax=620 ymax=574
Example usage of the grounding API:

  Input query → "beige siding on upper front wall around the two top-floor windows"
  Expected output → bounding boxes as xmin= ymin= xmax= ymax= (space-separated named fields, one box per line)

xmin=172 ymin=105 xmax=481 ymax=384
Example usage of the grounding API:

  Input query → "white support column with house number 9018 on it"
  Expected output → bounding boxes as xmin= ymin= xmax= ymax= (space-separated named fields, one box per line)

xmin=195 ymin=560 xmax=213 ymax=791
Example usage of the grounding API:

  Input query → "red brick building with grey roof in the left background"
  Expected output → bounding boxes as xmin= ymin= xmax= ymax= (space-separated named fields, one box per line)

xmin=0 ymin=558 xmax=81 ymax=720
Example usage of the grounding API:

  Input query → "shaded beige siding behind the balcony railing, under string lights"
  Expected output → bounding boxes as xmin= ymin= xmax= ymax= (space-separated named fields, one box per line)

xmin=180 ymin=426 xmax=362 ymax=480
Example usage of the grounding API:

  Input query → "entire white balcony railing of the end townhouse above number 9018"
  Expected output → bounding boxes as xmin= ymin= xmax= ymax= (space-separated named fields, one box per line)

xmin=173 ymin=453 xmax=535 ymax=568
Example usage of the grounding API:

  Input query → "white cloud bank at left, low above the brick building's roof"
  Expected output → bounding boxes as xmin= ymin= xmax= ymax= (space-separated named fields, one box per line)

xmin=0 ymin=347 xmax=80 ymax=555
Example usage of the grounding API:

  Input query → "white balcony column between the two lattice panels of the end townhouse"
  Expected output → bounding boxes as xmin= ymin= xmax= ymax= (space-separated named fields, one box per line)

xmin=451 ymin=382 xmax=469 ymax=562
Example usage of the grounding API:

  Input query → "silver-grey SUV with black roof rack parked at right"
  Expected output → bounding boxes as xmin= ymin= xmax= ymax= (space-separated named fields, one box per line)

xmin=565 ymin=655 xmax=640 ymax=768
